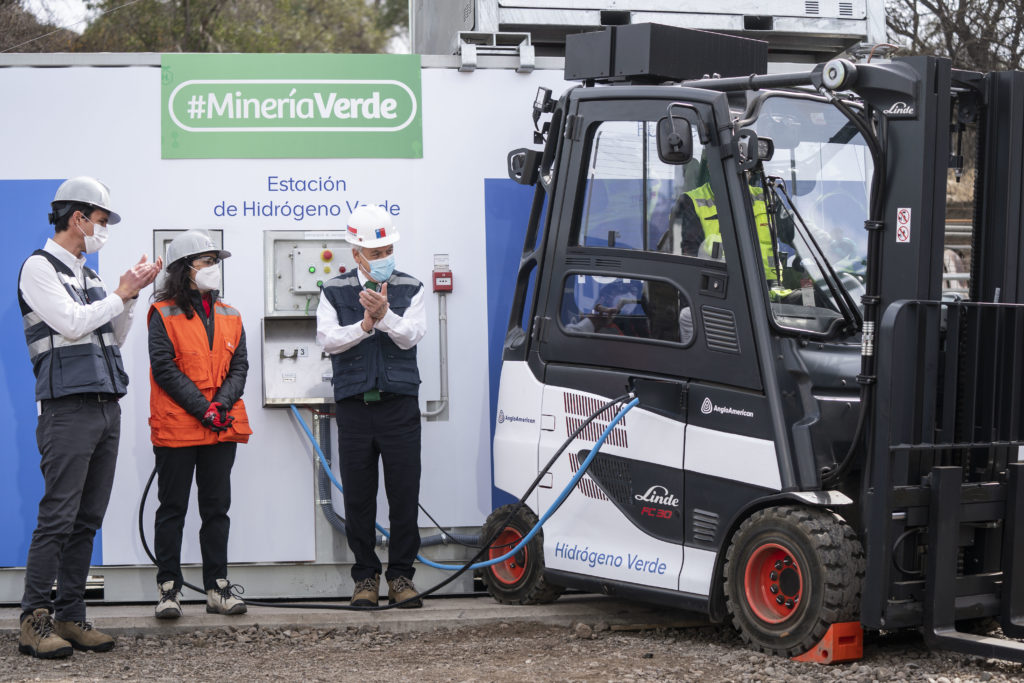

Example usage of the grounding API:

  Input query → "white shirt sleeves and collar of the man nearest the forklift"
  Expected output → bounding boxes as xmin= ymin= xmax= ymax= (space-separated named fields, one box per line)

xmin=316 ymin=270 xmax=427 ymax=354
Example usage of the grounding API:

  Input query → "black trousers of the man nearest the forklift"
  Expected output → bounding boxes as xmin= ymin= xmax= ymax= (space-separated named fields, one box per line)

xmin=338 ymin=396 xmax=421 ymax=581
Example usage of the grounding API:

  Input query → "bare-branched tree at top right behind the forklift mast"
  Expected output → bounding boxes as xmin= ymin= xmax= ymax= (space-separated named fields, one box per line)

xmin=886 ymin=0 xmax=1024 ymax=72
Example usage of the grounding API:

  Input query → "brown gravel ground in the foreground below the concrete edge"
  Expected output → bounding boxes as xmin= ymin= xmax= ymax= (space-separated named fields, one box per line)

xmin=0 ymin=623 xmax=1024 ymax=683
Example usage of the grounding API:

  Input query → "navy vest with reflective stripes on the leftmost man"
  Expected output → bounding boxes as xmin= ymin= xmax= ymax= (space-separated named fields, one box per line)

xmin=17 ymin=249 xmax=128 ymax=400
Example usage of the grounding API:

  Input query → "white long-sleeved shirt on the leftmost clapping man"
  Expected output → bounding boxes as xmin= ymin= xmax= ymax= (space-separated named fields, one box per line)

xmin=17 ymin=240 xmax=136 ymax=346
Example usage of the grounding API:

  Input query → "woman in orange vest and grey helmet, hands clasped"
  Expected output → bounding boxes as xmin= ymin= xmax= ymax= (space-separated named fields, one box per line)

xmin=148 ymin=230 xmax=252 ymax=618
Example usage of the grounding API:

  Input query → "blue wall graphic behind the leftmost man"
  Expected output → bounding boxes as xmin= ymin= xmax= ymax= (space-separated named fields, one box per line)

xmin=0 ymin=180 xmax=102 ymax=566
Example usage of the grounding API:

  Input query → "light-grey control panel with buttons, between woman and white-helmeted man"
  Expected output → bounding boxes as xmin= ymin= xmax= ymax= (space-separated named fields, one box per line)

xmin=262 ymin=230 xmax=355 ymax=405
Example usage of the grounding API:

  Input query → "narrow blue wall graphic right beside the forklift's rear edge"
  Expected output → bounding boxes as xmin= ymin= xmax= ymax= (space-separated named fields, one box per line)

xmin=483 ymin=178 xmax=534 ymax=508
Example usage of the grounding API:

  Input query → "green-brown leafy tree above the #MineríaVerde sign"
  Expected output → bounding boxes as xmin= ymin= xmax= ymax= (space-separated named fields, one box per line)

xmin=75 ymin=0 xmax=408 ymax=52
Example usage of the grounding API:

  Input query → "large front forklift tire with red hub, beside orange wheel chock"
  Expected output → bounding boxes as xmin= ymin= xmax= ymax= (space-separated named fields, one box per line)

xmin=724 ymin=506 xmax=864 ymax=656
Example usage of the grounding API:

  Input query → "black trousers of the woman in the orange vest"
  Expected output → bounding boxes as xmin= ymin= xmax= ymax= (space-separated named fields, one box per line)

xmin=153 ymin=441 xmax=238 ymax=591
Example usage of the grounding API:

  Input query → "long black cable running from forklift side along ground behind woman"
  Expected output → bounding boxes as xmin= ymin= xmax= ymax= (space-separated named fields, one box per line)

xmin=138 ymin=393 xmax=632 ymax=611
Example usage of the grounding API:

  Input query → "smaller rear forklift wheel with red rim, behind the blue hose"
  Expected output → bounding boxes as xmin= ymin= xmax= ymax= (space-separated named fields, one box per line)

xmin=479 ymin=505 xmax=565 ymax=605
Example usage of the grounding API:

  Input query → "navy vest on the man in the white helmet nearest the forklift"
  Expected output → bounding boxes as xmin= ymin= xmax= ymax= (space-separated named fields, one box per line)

xmin=323 ymin=270 xmax=423 ymax=400
